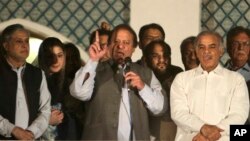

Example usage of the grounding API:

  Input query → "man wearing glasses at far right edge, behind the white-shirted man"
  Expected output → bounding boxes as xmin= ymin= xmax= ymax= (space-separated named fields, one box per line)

xmin=225 ymin=26 xmax=250 ymax=124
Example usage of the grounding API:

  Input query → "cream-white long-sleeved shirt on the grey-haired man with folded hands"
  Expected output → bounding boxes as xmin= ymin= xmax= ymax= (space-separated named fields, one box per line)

xmin=170 ymin=65 xmax=249 ymax=141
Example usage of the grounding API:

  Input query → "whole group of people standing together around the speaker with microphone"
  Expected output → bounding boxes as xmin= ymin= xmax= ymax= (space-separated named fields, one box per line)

xmin=0 ymin=23 xmax=250 ymax=141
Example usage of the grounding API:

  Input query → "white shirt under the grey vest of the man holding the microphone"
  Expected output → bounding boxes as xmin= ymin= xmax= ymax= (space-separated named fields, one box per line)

xmin=70 ymin=60 xmax=164 ymax=140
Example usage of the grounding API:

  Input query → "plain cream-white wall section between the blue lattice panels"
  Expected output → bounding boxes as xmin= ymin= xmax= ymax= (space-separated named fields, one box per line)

xmin=130 ymin=0 xmax=200 ymax=68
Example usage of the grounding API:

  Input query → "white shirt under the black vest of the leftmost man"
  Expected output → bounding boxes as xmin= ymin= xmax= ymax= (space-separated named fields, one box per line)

xmin=0 ymin=66 xmax=50 ymax=138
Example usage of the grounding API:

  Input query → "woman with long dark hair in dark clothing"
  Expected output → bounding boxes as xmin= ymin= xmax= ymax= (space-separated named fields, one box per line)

xmin=38 ymin=37 xmax=82 ymax=140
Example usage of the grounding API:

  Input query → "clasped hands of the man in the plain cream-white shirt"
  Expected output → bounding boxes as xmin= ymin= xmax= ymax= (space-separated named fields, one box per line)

xmin=200 ymin=124 xmax=224 ymax=141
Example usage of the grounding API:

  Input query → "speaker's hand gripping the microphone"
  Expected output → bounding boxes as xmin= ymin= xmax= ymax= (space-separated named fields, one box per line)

xmin=125 ymin=71 xmax=145 ymax=90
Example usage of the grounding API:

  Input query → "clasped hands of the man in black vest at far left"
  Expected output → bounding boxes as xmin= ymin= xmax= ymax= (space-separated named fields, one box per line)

xmin=11 ymin=126 xmax=35 ymax=140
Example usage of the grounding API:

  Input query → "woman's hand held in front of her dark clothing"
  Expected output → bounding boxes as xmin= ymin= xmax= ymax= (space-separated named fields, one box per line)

xmin=49 ymin=109 xmax=64 ymax=125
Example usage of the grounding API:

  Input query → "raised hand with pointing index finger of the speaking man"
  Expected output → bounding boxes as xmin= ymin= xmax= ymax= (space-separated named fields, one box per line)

xmin=89 ymin=31 xmax=108 ymax=61
